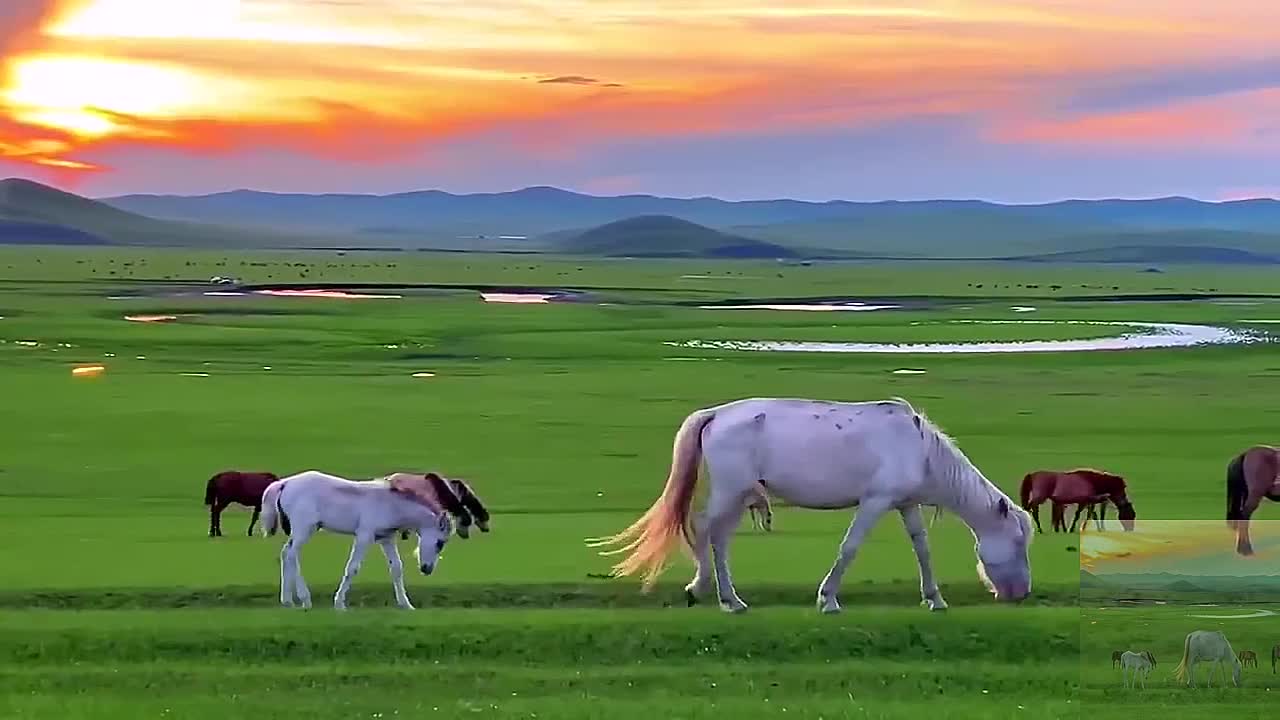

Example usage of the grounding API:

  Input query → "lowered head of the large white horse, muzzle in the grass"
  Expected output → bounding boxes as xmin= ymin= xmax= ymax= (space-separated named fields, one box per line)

xmin=973 ymin=497 xmax=1032 ymax=602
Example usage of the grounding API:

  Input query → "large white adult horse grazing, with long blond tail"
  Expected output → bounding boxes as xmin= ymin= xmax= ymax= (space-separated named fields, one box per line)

xmin=588 ymin=398 xmax=1033 ymax=612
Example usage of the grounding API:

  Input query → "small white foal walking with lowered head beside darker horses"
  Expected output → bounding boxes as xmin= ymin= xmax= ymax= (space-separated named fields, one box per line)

xmin=262 ymin=470 xmax=453 ymax=610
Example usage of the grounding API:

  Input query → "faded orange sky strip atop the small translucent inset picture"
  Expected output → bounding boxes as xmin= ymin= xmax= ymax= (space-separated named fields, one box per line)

xmin=1080 ymin=520 xmax=1280 ymax=575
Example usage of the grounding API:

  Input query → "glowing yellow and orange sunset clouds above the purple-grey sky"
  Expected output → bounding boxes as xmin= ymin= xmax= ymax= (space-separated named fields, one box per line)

xmin=0 ymin=0 xmax=1280 ymax=170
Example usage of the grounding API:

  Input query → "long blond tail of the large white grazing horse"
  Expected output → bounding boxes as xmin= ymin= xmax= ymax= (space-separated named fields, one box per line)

xmin=586 ymin=407 xmax=717 ymax=592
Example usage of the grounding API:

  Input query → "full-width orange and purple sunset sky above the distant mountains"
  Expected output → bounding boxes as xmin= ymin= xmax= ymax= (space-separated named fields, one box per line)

xmin=0 ymin=0 xmax=1280 ymax=202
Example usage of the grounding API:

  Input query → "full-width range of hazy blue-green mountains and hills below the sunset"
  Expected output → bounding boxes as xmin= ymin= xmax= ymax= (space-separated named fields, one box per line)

xmin=0 ymin=179 xmax=1280 ymax=264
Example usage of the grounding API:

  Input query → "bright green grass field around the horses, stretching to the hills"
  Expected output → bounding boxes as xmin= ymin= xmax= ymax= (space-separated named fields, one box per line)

xmin=0 ymin=249 xmax=1280 ymax=719
